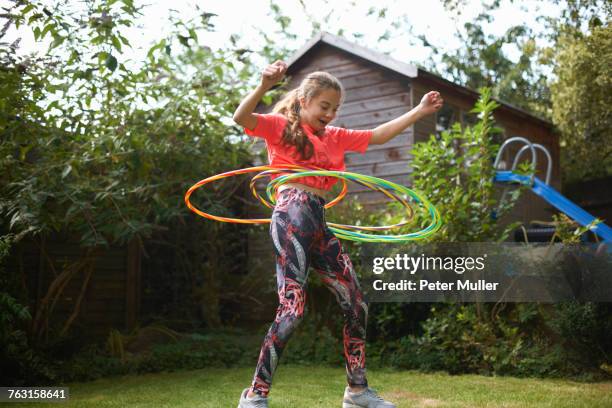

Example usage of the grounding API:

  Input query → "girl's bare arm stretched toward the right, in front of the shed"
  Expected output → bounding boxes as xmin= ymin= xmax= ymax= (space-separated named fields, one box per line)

xmin=370 ymin=91 xmax=444 ymax=145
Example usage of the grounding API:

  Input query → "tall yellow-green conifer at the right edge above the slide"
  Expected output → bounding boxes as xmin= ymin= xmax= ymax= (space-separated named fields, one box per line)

xmin=551 ymin=25 xmax=612 ymax=182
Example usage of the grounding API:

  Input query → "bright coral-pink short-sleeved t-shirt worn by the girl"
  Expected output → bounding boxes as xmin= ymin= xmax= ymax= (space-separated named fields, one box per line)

xmin=244 ymin=113 xmax=372 ymax=190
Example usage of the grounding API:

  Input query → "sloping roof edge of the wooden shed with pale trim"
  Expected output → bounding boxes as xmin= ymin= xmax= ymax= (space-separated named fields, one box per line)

xmin=287 ymin=31 xmax=553 ymax=128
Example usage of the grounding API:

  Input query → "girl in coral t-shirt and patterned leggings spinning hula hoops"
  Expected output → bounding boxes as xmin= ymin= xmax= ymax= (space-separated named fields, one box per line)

xmin=234 ymin=61 xmax=443 ymax=408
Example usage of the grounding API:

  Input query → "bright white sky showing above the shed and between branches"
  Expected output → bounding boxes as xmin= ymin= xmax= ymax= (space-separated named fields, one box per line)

xmin=0 ymin=0 xmax=559 ymax=71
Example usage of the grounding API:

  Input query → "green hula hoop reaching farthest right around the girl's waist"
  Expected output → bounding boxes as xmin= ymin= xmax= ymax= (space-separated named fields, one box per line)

xmin=266 ymin=170 xmax=442 ymax=242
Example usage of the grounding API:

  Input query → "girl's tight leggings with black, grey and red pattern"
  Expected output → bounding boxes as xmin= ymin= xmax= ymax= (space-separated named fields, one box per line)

xmin=252 ymin=188 xmax=368 ymax=397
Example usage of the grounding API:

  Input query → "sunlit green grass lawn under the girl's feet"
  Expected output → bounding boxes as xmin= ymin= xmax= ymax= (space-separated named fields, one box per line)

xmin=6 ymin=364 xmax=612 ymax=408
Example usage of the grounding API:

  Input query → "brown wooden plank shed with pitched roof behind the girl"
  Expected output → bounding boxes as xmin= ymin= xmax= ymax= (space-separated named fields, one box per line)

xmin=249 ymin=32 xmax=561 ymax=274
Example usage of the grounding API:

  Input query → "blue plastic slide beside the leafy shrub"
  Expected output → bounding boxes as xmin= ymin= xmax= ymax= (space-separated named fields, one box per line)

xmin=494 ymin=171 xmax=612 ymax=242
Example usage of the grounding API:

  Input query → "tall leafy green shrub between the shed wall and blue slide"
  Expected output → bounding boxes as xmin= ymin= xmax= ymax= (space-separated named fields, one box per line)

xmin=412 ymin=88 xmax=521 ymax=242
